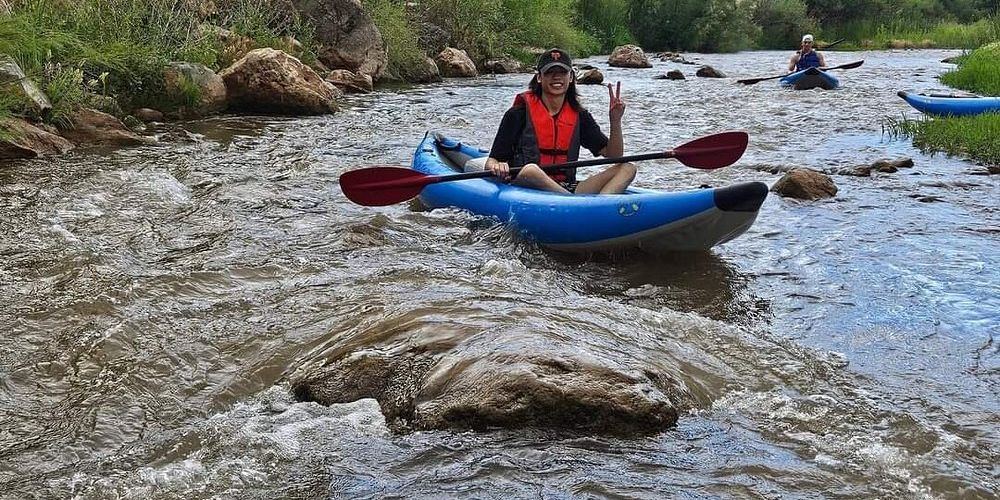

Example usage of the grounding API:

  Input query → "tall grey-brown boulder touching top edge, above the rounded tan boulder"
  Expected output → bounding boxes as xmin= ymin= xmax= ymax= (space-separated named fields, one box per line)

xmin=289 ymin=0 xmax=389 ymax=80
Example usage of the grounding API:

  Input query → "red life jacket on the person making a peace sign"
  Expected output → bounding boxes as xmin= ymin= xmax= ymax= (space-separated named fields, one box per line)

xmin=514 ymin=91 xmax=580 ymax=182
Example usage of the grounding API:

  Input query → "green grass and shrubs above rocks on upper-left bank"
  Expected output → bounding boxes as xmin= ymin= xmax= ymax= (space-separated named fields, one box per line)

xmin=0 ymin=0 xmax=315 ymax=123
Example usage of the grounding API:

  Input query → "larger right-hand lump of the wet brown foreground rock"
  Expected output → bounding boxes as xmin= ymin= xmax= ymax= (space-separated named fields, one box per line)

xmin=413 ymin=353 xmax=677 ymax=435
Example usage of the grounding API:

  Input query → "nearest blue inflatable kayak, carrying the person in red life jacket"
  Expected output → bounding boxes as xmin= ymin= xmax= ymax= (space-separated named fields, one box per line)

xmin=413 ymin=134 xmax=768 ymax=255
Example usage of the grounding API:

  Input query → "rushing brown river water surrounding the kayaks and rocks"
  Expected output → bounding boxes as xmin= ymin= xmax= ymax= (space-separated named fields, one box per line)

xmin=0 ymin=51 xmax=1000 ymax=499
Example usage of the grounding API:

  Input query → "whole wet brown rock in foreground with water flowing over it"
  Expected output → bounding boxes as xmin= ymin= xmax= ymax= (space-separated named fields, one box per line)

xmin=291 ymin=332 xmax=683 ymax=435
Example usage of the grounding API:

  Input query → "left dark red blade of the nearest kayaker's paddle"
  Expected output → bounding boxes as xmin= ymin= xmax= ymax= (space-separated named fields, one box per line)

xmin=340 ymin=167 xmax=436 ymax=207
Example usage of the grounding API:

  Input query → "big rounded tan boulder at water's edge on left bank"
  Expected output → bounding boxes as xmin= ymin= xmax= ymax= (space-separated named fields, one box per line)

xmin=219 ymin=48 xmax=339 ymax=115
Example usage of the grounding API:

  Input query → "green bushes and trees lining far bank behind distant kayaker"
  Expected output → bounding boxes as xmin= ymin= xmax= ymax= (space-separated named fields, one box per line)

xmin=363 ymin=0 xmax=1000 ymax=70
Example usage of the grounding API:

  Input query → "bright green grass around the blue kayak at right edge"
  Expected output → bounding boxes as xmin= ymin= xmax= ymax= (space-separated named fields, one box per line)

xmin=887 ymin=43 xmax=1000 ymax=166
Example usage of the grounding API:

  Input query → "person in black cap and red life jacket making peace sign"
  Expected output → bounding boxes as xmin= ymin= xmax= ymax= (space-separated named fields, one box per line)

xmin=486 ymin=49 xmax=636 ymax=193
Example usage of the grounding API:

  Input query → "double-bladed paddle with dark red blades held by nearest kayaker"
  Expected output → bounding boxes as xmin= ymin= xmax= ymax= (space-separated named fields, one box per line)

xmin=340 ymin=131 xmax=750 ymax=207
